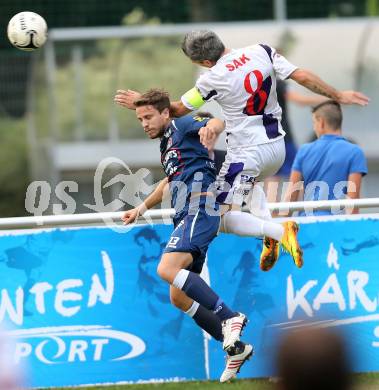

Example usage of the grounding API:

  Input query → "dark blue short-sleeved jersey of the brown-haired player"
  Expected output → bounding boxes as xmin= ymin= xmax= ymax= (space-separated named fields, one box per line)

xmin=161 ymin=115 xmax=216 ymax=221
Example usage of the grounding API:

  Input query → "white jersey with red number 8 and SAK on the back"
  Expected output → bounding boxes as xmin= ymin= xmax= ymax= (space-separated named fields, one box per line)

xmin=182 ymin=44 xmax=297 ymax=147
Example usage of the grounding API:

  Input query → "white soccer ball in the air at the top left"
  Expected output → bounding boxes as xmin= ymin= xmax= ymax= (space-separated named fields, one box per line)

xmin=7 ymin=11 xmax=47 ymax=51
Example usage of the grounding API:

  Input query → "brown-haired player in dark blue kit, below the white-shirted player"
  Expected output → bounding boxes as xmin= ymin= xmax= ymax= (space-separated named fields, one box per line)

xmin=122 ymin=89 xmax=252 ymax=382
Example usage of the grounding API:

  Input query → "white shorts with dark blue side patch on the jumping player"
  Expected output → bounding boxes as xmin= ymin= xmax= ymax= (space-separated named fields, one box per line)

xmin=216 ymin=137 xmax=286 ymax=206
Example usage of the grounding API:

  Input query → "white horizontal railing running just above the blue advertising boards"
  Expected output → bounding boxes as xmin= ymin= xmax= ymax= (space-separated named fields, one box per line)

xmin=0 ymin=198 xmax=379 ymax=230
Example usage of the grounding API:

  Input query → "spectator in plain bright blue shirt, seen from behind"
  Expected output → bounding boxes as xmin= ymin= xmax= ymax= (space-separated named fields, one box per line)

xmin=286 ymin=100 xmax=367 ymax=215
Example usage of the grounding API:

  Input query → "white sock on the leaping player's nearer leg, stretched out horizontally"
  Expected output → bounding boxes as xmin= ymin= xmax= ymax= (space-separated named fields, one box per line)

xmin=220 ymin=211 xmax=284 ymax=241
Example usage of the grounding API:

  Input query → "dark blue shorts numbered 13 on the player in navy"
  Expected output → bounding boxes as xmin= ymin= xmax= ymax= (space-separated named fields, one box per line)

xmin=163 ymin=206 xmax=220 ymax=274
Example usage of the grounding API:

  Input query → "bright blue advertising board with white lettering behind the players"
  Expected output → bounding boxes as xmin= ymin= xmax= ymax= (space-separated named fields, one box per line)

xmin=0 ymin=218 xmax=379 ymax=387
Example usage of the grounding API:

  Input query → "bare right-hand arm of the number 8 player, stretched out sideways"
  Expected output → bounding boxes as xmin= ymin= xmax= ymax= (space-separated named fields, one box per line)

xmin=289 ymin=69 xmax=370 ymax=106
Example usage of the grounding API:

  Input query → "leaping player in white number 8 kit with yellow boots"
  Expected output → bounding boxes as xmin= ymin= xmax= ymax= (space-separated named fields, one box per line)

xmin=115 ymin=30 xmax=368 ymax=271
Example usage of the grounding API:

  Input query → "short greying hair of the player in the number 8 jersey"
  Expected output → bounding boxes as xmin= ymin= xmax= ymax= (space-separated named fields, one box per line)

xmin=182 ymin=30 xmax=225 ymax=62
